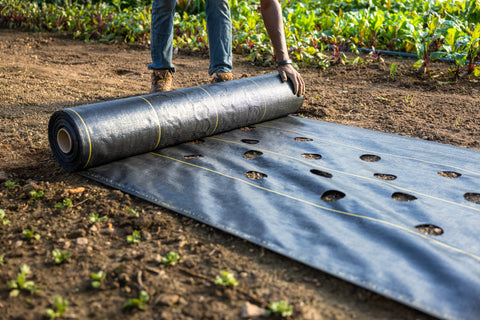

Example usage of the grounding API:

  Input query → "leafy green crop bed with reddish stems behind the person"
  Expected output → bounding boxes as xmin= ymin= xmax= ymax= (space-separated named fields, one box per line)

xmin=0 ymin=0 xmax=480 ymax=76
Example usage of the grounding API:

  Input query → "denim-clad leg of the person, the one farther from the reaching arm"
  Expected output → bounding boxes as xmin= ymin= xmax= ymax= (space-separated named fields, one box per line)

xmin=148 ymin=0 xmax=176 ymax=73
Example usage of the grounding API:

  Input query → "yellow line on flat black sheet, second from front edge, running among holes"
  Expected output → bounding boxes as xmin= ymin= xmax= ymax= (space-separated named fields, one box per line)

xmin=208 ymin=137 xmax=480 ymax=212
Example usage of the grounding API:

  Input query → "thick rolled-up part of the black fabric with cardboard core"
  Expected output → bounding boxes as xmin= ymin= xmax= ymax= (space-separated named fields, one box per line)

xmin=48 ymin=74 xmax=303 ymax=171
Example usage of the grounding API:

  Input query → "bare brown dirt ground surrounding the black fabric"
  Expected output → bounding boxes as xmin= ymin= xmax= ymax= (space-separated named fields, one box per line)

xmin=0 ymin=29 xmax=480 ymax=319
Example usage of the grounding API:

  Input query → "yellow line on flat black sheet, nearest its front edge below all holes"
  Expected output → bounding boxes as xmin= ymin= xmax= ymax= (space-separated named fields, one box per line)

xmin=150 ymin=152 xmax=480 ymax=261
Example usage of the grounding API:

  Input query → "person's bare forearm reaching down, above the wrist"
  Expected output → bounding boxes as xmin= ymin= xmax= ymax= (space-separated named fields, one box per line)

xmin=260 ymin=0 xmax=289 ymax=61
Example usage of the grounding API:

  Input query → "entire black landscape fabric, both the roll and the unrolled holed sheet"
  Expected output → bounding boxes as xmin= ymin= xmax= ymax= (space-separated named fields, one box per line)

xmin=49 ymin=75 xmax=480 ymax=319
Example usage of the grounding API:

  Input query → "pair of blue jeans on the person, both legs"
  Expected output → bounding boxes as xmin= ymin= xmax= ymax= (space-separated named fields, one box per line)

xmin=148 ymin=0 xmax=232 ymax=75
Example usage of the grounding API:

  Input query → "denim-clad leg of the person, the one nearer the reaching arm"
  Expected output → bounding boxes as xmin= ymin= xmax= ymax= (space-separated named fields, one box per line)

xmin=205 ymin=0 xmax=232 ymax=76
